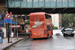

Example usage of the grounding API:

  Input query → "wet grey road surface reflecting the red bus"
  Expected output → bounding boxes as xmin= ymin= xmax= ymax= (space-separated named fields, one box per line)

xmin=9 ymin=30 xmax=75 ymax=50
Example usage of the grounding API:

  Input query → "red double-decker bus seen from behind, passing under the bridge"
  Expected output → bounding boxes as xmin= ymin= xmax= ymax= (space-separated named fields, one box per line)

xmin=30 ymin=12 xmax=53 ymax=38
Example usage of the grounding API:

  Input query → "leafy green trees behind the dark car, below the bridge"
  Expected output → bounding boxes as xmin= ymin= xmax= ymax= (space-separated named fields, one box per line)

xmin=62 ymin=14 xmax=75 ymax=27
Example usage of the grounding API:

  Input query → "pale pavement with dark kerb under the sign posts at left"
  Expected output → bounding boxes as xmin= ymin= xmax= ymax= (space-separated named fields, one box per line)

xmin=0 ymin=36 xmax=27 ymax=50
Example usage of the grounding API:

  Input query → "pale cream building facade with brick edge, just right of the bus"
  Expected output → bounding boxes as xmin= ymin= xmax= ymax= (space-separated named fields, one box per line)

xmin=51 ymin=14 xmax=62 ymax=28
